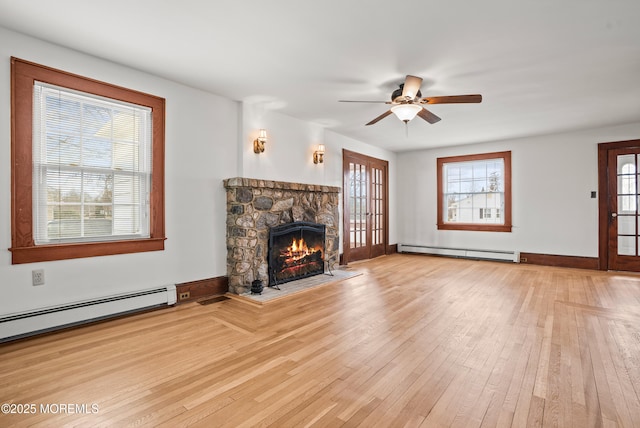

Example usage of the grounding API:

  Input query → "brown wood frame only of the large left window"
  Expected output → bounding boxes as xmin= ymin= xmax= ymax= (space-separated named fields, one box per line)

xmin=9 ymin=57 xmax=166 ymax=264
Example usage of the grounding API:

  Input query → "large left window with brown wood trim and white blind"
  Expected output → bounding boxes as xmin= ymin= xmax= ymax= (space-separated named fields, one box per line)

xmin=10 ymin=58 xmax=165 ymax=264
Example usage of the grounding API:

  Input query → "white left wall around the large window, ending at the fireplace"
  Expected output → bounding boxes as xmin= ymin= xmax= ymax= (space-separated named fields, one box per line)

xmin=0 ymin=28 xmax=239 ymax=314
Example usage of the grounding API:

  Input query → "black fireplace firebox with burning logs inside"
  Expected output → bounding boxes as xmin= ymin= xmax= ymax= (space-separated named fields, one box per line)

xmin=268 ymin=221 xmax=326 ymax=287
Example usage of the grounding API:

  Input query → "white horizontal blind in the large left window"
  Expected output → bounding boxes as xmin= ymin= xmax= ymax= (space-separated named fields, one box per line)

xmin=33 ymin=82 xmax=152 ymax=245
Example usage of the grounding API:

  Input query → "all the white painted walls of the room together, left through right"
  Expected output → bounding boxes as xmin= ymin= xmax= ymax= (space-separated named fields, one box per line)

xmin=0 ymin=28 xmax=640 ymax=322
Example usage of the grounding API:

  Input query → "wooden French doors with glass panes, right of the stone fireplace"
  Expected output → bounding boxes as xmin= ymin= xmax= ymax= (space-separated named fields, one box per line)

xmin=343 ymin=150 xmax=389 ymax=263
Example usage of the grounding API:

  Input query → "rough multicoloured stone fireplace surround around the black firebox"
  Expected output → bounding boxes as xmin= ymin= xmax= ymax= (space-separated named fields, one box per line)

xmin=224 ymin=177 xmax=341 ymax=294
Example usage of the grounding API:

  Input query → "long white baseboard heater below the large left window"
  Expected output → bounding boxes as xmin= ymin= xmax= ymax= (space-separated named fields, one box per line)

xmin=0 ymin=284 xmax=176 ymax=343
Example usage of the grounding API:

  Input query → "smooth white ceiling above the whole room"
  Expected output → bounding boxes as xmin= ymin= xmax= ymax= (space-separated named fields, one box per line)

xmin=0 ymin=0 xmax=640 ymax=151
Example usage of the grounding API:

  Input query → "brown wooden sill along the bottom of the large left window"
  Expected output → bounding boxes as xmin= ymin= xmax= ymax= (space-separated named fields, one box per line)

xmin=9 ymin=238 xmax=166 ymax=265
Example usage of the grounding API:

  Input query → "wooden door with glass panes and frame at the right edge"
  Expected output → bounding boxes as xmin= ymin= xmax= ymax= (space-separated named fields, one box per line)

xmin=598 ymin=140 xmax=640 ymax=272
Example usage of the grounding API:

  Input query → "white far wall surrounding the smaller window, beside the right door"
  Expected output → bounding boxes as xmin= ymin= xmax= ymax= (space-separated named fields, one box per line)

xmin=396 ymin=122 xmax=640 ymax=257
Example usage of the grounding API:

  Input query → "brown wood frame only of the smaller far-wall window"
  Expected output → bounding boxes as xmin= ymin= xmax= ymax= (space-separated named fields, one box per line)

xmin=437 ymin=151 xmax=512 ymax=232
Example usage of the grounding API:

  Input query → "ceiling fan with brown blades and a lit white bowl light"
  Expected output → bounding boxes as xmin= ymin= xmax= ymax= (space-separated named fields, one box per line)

xmin=339 ymin=75 xmax=482 ymax=125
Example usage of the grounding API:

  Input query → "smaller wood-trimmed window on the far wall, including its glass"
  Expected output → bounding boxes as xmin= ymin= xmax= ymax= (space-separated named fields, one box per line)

xmin=437 ymin=152 xmax=511 ymax=232
